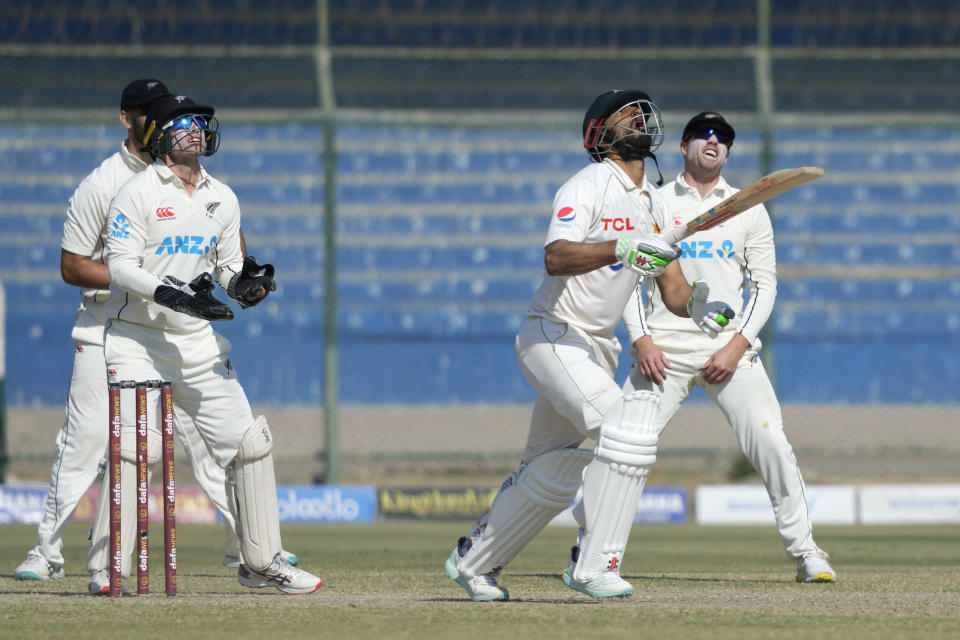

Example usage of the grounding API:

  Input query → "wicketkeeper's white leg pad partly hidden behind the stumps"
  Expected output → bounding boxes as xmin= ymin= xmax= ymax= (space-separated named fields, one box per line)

xmin=87 ymin=427 xmax=161 ymax=577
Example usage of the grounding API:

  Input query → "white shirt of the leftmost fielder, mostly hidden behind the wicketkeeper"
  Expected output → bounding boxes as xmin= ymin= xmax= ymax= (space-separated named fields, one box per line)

xmin=60 ymin=141 xmax=147 ymax=346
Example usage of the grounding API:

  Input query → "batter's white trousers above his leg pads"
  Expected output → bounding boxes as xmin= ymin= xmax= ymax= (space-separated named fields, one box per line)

xmin=516 ymin=316 xmax=623 ymax=460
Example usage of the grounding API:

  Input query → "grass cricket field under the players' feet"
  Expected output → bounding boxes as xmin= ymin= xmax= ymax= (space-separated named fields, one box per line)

xmin=0 ymin=522 xmax=960 ymax=640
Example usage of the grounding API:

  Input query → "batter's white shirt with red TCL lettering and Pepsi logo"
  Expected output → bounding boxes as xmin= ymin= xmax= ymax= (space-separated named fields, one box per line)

xmin=527 ymin=160 xmax=668 ymax=340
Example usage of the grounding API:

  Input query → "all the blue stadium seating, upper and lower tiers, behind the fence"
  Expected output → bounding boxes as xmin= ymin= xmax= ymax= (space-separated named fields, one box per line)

xmin=0 ymin=0 xmax=960 ymax=405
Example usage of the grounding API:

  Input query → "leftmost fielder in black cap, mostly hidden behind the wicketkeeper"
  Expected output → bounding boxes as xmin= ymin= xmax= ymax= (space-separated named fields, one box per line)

xmin=14 ymin=79 xmax=296 ymax=593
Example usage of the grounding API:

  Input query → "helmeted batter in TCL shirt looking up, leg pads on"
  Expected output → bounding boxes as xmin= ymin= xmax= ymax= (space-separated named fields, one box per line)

xmin=445 ymin=90 xmax=733 ymax=600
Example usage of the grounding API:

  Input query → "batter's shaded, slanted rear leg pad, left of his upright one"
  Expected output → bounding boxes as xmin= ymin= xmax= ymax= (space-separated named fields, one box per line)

xmin=457 ymin=449 xmax=593 ymax=579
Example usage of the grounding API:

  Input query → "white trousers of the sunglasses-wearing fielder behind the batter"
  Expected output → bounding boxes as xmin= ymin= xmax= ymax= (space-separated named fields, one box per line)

xmin=624 ymin=332 xmax=822 ymax=558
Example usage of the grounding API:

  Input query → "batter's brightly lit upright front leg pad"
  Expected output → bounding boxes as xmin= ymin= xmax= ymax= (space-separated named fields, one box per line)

xmin=573 ymin=391 xmax=660 ymax=582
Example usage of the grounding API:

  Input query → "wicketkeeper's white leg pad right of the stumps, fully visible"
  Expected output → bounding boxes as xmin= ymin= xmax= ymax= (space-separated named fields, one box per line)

xmin=226 ymin=416 xmax=281 ymax=571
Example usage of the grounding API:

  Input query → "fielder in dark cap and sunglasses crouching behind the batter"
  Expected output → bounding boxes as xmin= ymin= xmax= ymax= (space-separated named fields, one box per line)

xmin=624 ymin=112 xmax=836 ymax=582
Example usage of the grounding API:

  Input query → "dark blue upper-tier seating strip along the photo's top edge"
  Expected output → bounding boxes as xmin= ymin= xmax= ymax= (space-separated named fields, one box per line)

xmin=0 ymin=0 xmax=956 ymax=48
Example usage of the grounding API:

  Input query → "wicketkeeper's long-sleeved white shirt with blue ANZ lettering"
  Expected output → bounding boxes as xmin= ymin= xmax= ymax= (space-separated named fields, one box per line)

xmin=104 ymin=161 xmax=243 ymax=333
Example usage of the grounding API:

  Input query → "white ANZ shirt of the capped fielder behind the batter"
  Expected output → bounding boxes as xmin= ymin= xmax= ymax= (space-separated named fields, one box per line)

xmin=647 ymin=174 xmax=777 ymax=349
